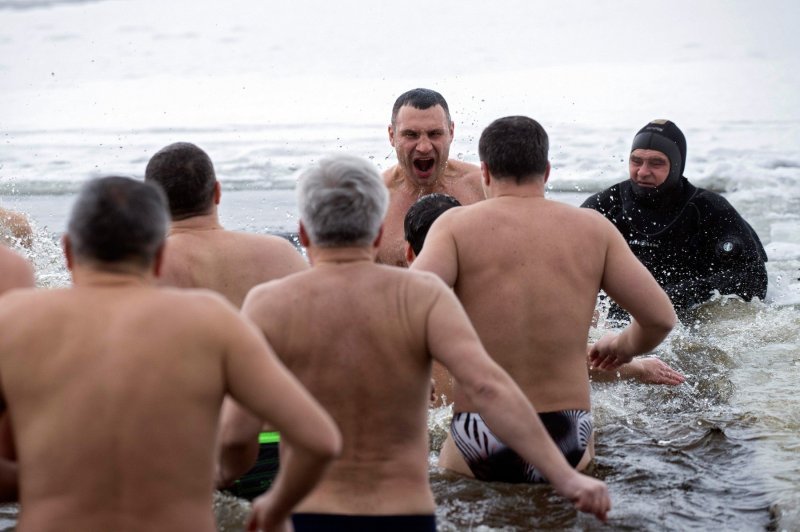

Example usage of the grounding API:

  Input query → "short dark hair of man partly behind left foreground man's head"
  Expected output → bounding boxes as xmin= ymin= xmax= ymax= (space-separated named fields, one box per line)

xmin=144 ymin=142 xmax=217 ymax=220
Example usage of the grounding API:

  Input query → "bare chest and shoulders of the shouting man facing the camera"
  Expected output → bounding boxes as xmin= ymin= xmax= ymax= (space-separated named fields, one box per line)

xmin=378 ymin=159 xmax=486 ymax=267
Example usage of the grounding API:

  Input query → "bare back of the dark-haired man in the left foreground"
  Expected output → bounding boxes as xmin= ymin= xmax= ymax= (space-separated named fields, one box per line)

xmin=0 ymin=287 xmax=235 ymax=531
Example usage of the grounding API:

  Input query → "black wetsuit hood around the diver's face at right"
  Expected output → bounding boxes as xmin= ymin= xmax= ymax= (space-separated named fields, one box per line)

xmin=631 ymin=120 xmax=686 ymax=202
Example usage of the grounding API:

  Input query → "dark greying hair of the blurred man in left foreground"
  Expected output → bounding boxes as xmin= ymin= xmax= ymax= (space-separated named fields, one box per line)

xmin=67 ymin=176 xmax=169 ymax=270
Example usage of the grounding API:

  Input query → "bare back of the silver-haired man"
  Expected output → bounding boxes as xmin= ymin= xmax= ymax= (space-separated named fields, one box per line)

xmin=244 ymin=256 xmax=446 ymax=514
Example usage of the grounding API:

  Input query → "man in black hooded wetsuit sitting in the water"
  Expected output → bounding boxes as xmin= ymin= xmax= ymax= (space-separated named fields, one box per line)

xmin=581 ymin=120 xmax=767 ymax=320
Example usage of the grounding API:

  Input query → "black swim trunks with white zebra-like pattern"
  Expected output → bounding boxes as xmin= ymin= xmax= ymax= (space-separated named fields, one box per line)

xmin=450 ymin=410 xmax=593 ymax=483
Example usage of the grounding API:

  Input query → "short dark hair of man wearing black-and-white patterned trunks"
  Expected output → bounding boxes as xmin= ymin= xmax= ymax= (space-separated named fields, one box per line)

xmin=478 ymin=116 xmax=550 ymax=183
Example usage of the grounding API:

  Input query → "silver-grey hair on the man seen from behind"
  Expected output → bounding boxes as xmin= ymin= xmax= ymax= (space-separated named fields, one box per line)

xmin=297 ymin=155 xmax=389 ymax=247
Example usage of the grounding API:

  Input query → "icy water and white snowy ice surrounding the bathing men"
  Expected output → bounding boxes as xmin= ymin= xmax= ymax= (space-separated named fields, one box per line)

xmin=0 ymin=0 xmax=800 ymax=531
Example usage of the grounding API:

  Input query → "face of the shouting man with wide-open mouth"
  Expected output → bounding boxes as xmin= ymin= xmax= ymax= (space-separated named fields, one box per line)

xmin=389 ymin=105 xmax=453 ymax=186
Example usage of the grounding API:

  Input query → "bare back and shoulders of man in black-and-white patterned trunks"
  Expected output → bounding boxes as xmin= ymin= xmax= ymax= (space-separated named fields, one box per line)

xmin=413 ymin=196 xmax=656 ymax=412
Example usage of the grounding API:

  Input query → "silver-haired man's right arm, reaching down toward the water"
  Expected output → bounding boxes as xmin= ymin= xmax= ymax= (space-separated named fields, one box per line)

xmin=427 ymin=283 xmax=611 ymax=520
